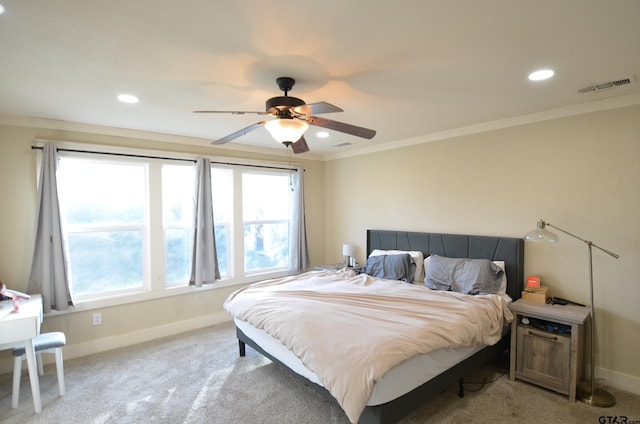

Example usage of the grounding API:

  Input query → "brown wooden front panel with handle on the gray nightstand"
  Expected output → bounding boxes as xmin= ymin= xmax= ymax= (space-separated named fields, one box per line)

xmin=516 ymin=326 xmax=571 ymax=394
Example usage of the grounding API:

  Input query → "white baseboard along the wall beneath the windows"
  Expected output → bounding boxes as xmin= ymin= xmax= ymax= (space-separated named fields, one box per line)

xmin=0 ymin=311 xmax=231 ymax=374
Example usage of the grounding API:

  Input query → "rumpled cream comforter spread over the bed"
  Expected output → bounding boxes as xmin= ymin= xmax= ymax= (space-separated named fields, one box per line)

xmin=224 ymin=270 xmax=513 ymax=423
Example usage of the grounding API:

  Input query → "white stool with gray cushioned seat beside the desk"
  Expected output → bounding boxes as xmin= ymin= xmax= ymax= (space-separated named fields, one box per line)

xmin=11 ymin=331 xmax=67 ymax=408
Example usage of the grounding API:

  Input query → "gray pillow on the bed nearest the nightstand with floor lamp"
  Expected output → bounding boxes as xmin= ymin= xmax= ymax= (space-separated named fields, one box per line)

xmin=424 ymin=255 xmax=504 ymax=294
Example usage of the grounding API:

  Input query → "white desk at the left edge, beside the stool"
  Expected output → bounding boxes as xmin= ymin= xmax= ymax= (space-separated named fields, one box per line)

xmin=0 ymin=294 xmax=42 ymax=414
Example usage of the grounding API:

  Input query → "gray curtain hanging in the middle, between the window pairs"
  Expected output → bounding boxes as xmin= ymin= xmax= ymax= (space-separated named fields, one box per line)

xmin=189 ymin=158 xmax=220 ymax=287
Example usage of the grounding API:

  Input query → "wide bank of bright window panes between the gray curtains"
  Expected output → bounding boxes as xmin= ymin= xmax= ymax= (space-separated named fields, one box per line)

xmin=53 ymin=152 xmax=291 ymax=304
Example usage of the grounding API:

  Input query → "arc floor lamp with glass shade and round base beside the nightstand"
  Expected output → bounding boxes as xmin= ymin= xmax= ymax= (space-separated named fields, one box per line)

xmin=524 ymin=220 xmax=620 ymax=407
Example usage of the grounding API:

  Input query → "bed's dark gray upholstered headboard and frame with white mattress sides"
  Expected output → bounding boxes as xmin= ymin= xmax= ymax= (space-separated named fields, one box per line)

xmin=228 ymin=230 xmax=524 ymax=424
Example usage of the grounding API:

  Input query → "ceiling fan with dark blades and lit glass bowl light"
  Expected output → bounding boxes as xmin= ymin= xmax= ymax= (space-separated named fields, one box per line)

xmin=194 ymin=77 xmax=376 ymax=153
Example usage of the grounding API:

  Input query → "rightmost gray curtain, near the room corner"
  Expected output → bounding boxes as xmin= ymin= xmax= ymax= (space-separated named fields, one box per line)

xmin=289 ymin=167 xmax=310 ymax=274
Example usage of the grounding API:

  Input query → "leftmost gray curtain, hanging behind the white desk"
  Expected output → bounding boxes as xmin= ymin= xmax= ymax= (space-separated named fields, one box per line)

xmin=27 ymin=144 xmax=73 ymax=313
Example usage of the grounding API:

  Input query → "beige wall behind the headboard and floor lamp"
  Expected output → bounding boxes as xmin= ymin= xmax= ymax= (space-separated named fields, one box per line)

xmin=324 ymin=106 xmax=640 ymax=393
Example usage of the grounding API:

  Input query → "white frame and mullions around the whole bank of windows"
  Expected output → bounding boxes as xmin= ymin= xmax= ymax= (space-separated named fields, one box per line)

xmin=45 ymin=142 xmax=298 ymax=314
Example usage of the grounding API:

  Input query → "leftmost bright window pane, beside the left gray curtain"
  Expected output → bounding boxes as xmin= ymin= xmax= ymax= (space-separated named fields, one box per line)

xmin=58 ymin=158 xmax=148 ymax=298
